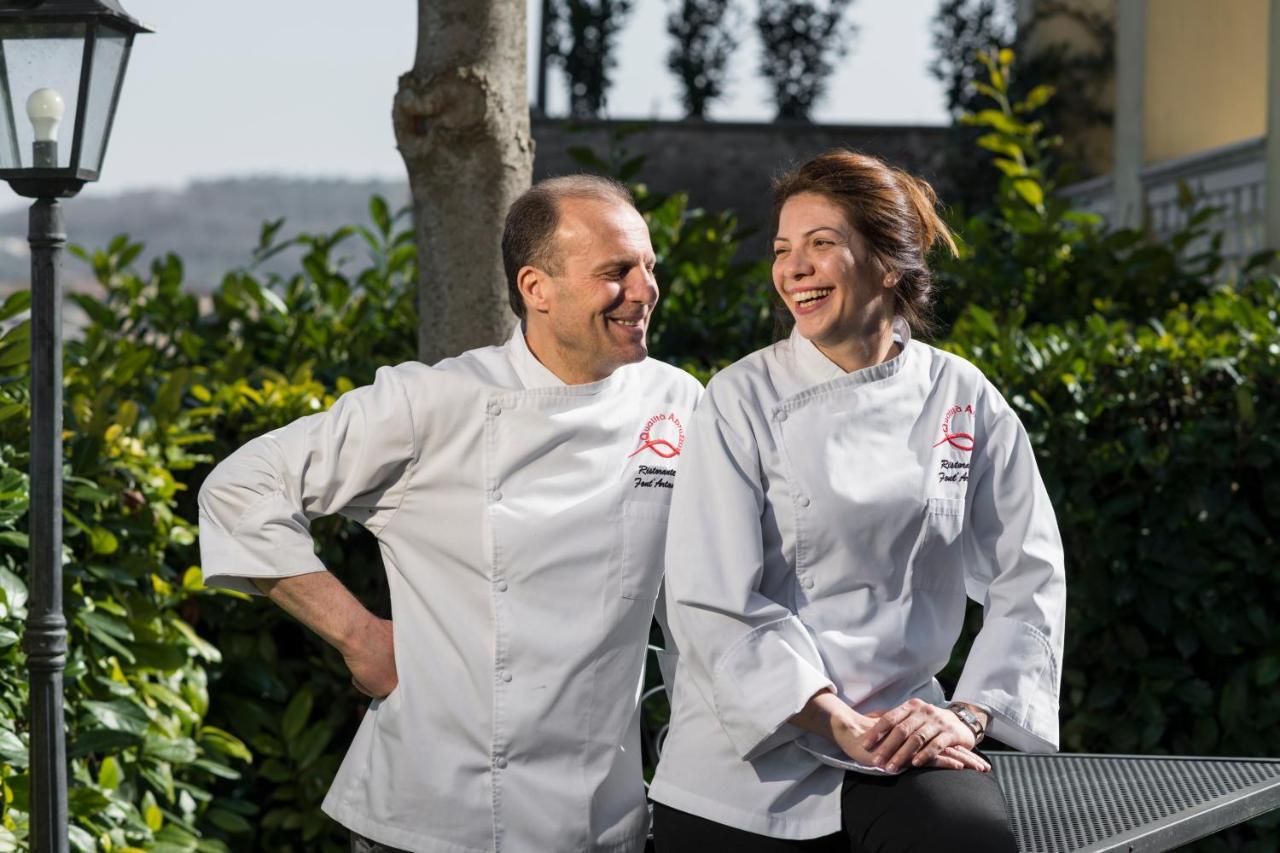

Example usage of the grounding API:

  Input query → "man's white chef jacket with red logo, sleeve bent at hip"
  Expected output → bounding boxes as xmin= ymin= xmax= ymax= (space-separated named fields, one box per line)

xmin=200 ymin=329 xmax=701 ymax=853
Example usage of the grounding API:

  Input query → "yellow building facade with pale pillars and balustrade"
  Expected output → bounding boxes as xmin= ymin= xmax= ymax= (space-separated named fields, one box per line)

xmin=1039 ymin=0 xmax=1280 ymax=263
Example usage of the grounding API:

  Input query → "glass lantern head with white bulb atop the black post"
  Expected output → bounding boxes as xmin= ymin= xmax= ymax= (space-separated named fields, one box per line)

xmin=0 ymin=0 xmax=150 ymax=199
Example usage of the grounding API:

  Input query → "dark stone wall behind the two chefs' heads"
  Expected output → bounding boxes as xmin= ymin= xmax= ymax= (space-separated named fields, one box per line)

xmin=524 ymin=119 xmax=950 ymax=225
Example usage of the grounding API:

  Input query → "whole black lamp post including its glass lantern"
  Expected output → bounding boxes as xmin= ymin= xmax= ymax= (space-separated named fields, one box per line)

xmin=0 ymin=0 xmax=150 ymax=853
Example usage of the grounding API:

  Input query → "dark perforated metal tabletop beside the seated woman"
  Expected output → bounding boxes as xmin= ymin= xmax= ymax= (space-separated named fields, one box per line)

xmin=986 ymin=752 xmax=1280 ymax=853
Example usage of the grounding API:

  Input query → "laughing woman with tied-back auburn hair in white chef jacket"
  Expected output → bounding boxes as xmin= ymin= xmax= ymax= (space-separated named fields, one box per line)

xmin=650 ymin=151 xmax=1065 ymax=853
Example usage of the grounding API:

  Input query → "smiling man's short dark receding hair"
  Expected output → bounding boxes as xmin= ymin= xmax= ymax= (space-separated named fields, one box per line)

xmin=502 ymin=174 xmax=636 ymax=320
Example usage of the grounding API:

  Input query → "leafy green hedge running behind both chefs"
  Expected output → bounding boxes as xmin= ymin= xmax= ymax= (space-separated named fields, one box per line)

xmin=0 ymin=56 xmax=1280 ymax=852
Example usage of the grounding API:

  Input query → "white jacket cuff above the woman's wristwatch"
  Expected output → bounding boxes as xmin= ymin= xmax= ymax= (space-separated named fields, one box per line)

xmin=951 ymin=616 xmax=1059 ymax=752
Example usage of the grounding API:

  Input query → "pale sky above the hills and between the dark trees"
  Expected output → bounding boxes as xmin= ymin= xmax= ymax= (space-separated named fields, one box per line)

xmin=0 ymin=0 xmax=946 ymax=207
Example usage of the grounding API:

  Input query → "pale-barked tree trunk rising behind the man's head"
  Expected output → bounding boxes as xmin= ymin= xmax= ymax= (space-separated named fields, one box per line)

xmin=392 ymin=0 xmax=534 ymax=364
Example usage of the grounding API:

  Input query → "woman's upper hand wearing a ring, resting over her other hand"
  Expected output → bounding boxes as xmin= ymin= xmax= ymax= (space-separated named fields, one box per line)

xmin=859 ymin=699 xmax=991 ymax=772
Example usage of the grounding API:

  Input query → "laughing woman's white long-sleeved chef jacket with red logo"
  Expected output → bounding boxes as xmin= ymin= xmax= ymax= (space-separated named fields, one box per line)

xmin=650 ymin=323 xmax=1065 ymax=839
